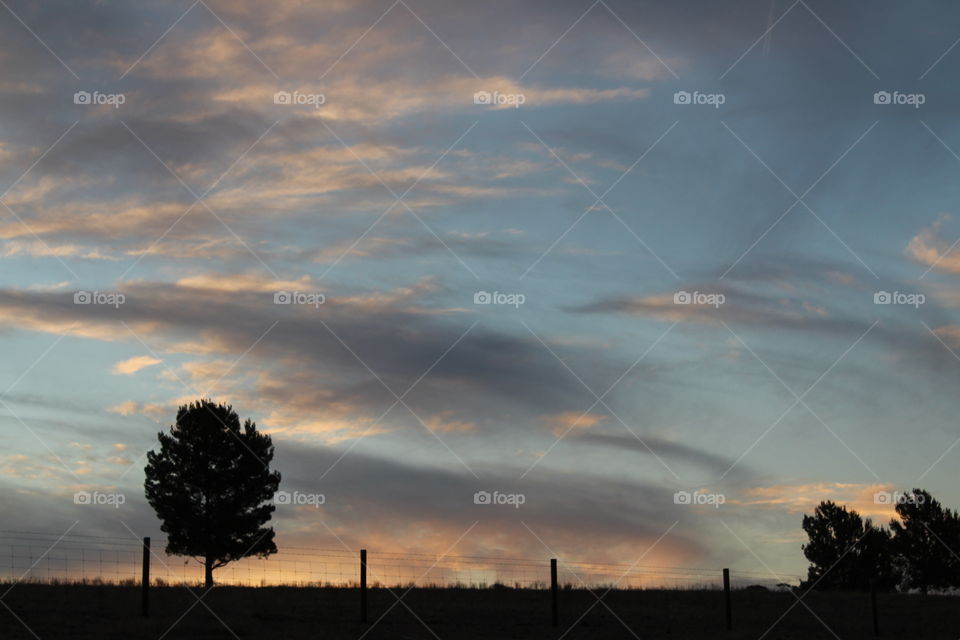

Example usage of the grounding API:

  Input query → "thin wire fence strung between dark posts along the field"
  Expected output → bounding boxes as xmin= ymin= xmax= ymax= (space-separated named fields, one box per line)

xmin=0 ymin=531 xmax=800 ymax=589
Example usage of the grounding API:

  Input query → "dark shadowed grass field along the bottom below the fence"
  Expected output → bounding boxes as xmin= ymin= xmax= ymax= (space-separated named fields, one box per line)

xmin=0 ymin=584 xmax=960 ymax=640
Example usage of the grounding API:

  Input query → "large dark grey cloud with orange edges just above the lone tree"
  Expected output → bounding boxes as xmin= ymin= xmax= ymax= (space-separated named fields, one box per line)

xmin=0 ymin=276 xmax=640 ymax=444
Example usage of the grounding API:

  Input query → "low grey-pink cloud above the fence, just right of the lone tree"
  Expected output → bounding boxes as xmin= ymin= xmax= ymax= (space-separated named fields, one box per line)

xmin=264 ymin=445 xmax=708 ymax=564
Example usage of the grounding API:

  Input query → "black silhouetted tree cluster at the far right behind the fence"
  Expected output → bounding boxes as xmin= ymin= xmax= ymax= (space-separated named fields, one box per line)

xmin=803 ymin=489 xmax=960 ymax=593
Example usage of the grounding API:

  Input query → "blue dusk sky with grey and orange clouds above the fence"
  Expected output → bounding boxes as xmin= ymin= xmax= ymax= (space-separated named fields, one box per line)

xmin=0 ymin=0 xmax=960 ymax=577
